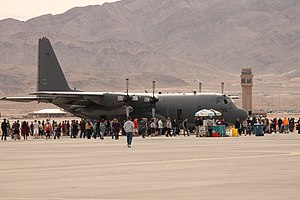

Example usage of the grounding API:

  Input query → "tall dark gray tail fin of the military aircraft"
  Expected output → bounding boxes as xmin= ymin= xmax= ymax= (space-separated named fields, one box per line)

xmin=37 ymin=37 xmax=71 ymax=91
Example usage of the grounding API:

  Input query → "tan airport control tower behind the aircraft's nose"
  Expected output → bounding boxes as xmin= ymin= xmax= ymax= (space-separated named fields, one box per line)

xmin=241 ymin=68 xmax=253 ymax=115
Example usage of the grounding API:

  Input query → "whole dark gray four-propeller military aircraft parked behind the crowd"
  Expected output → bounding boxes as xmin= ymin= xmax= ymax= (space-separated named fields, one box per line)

xmin=1 ymin=37 xmax=247 ymax=123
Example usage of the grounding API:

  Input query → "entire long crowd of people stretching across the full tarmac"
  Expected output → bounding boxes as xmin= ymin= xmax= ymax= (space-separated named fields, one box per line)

xmin=1 ymin=117 xmax=300 ymax=142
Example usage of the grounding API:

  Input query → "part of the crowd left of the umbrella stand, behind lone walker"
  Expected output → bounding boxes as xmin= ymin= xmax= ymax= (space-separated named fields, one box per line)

xmin=1 ymin=118 xmax=185 ymax=140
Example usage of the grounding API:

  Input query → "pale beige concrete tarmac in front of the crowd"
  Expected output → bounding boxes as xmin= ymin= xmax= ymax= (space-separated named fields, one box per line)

xmin=0 ymin=133 xmax=300 ymax=200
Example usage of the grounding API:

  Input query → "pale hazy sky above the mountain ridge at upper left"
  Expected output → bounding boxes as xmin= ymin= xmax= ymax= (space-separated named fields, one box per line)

xmin=0 ymin=0 xmax=117 ymax=21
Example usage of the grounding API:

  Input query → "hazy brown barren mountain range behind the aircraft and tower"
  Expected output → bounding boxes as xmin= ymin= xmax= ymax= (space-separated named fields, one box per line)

xmin=0 ymin=0 xmax=300 ymax=111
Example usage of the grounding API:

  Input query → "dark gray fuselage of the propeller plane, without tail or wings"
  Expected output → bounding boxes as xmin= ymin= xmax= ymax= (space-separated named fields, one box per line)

xmin=52 ymin=93 xmax=247 ymax=123
